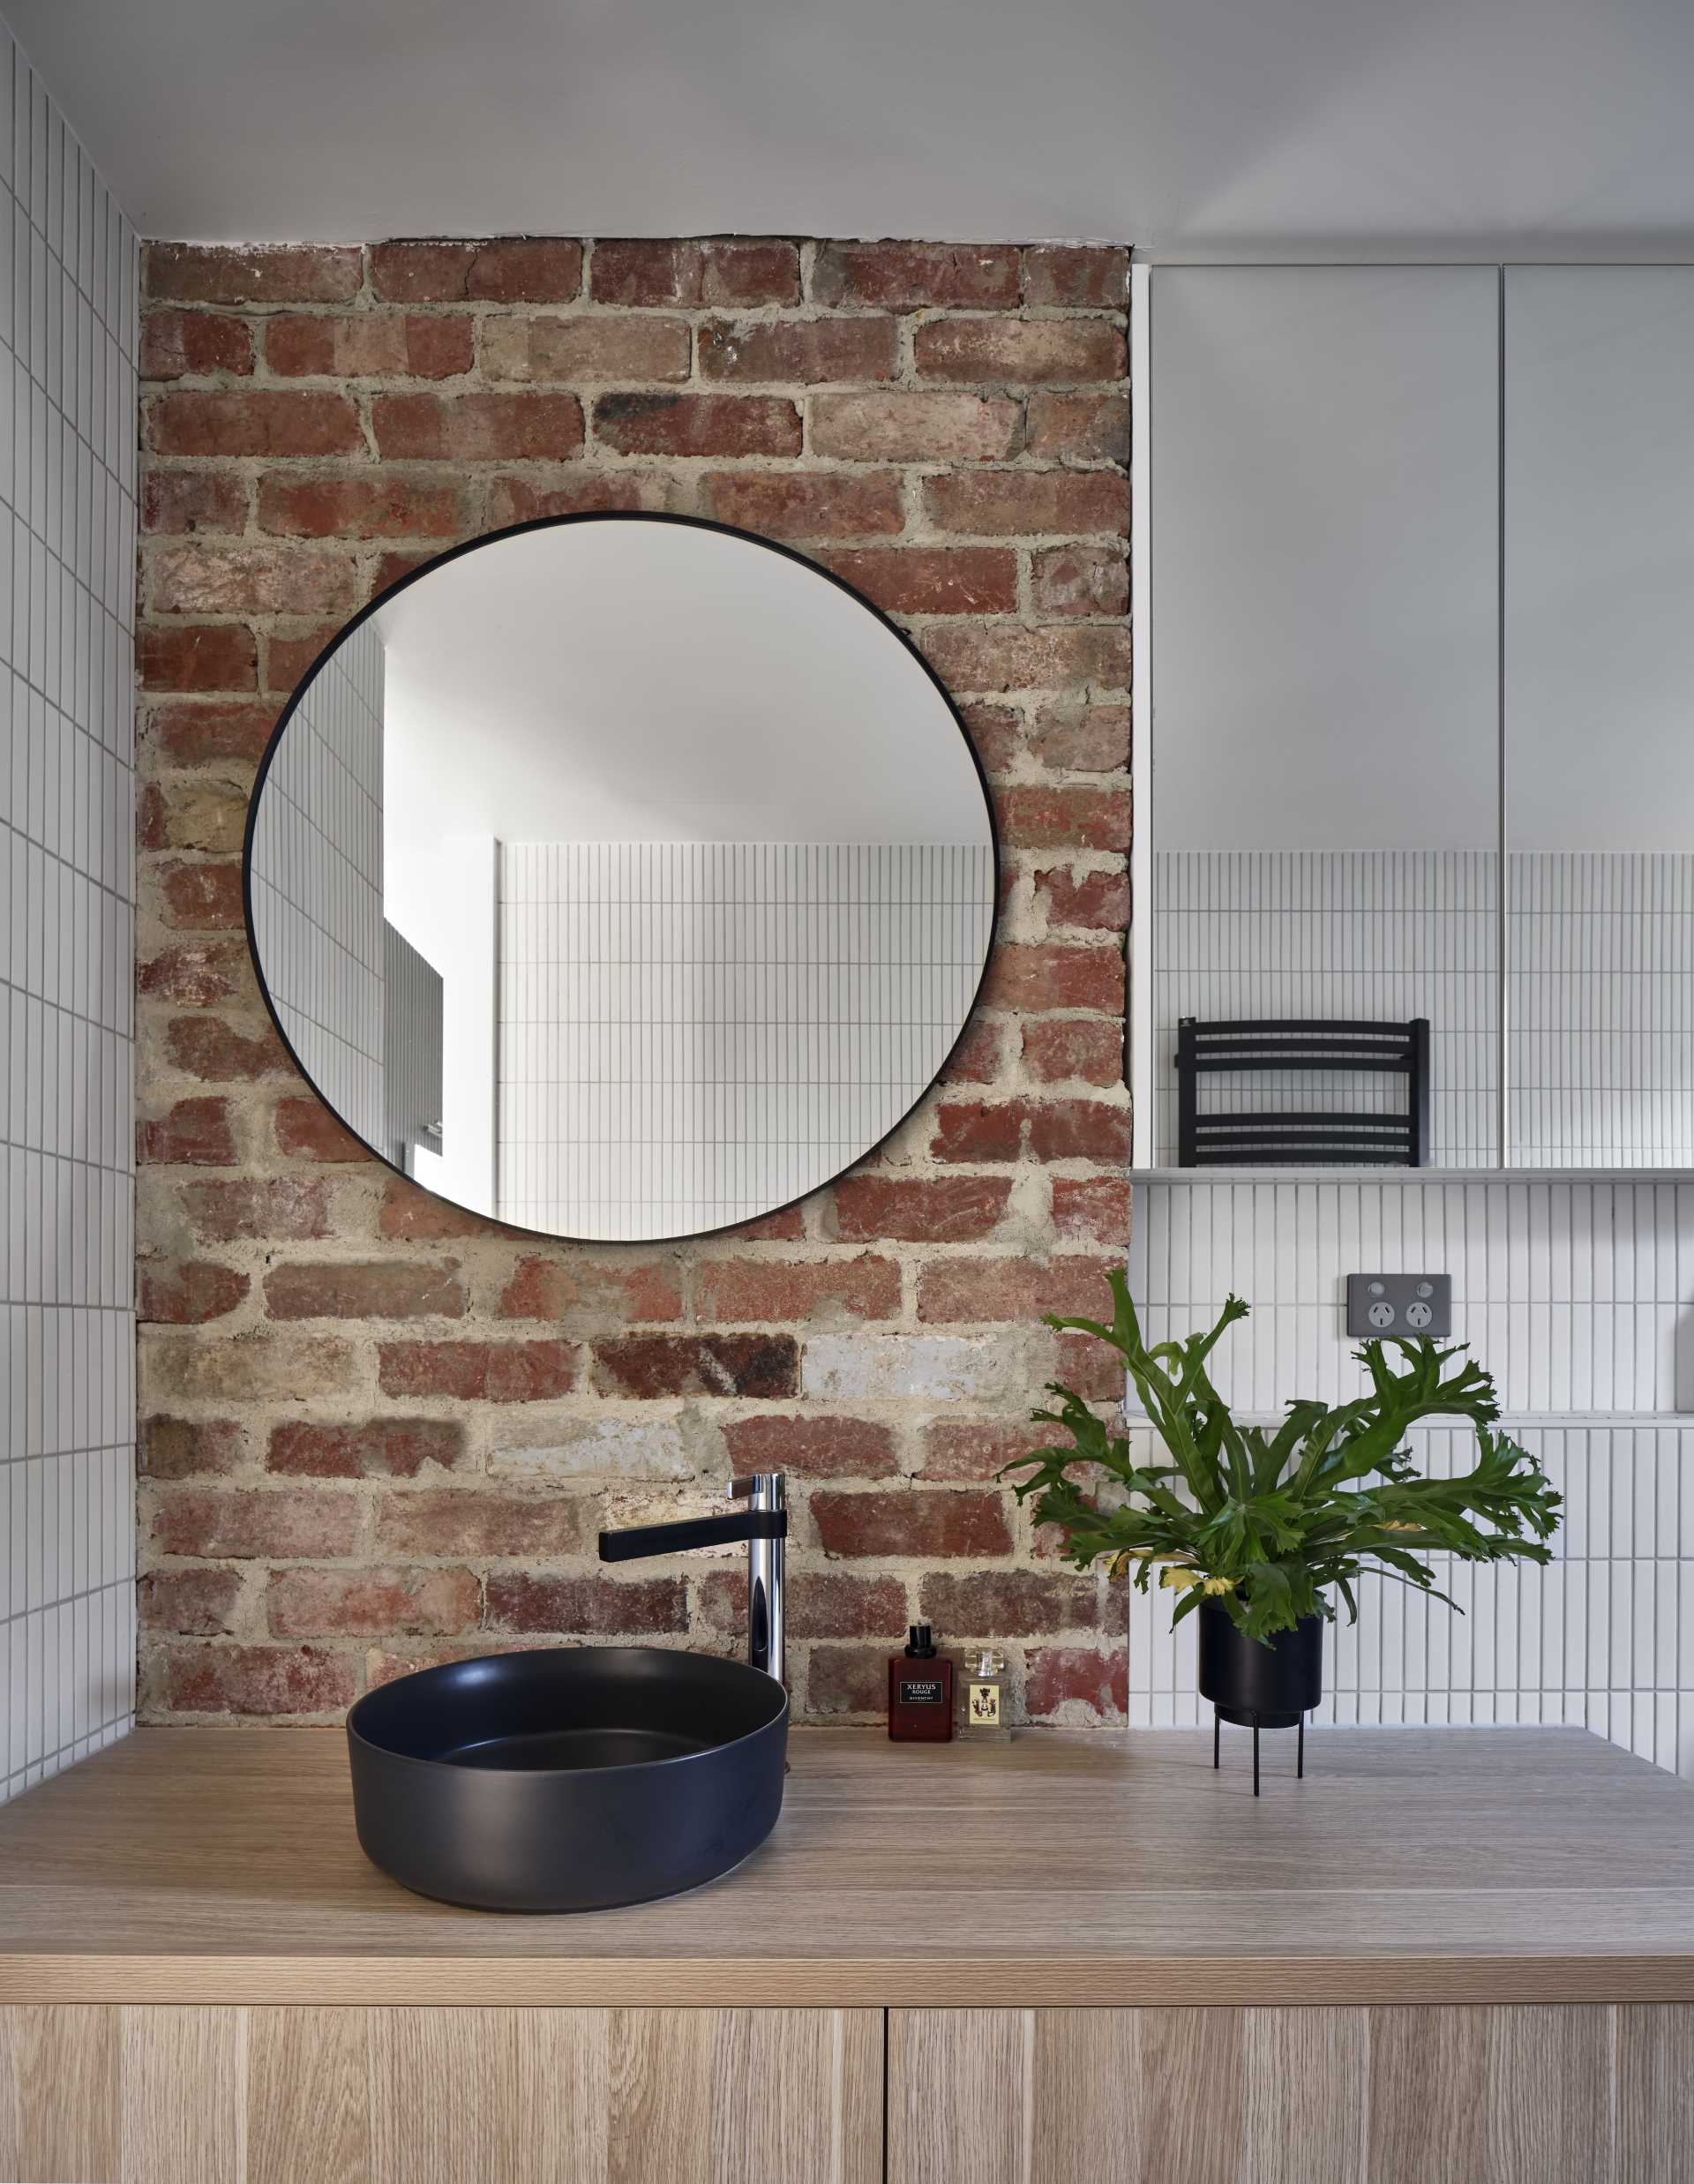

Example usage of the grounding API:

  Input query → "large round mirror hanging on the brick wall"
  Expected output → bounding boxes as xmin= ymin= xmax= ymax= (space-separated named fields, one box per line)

xmin=247 ymin=502 xmax=995 ymax=1241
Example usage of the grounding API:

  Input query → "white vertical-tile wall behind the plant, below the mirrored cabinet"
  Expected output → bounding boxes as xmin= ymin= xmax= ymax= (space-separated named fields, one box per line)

xmin=1128 ymin=1175 xmax=1694 ymax=1775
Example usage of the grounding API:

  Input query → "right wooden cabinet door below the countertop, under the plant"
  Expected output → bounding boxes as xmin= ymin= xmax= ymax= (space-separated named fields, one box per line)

xmin=888 ymin=2003 xmax=1694 ymax=2184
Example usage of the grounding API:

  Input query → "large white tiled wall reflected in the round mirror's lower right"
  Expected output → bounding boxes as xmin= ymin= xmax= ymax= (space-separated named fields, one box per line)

xmin=500 ymin=841 xmax=993 ymax=1238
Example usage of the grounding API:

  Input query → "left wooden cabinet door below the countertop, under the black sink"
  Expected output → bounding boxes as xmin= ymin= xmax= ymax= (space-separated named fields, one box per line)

xmin=0 ymin=2008 xmax=882 ymax=2184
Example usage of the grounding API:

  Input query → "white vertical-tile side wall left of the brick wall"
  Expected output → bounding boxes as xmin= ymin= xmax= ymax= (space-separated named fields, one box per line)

xmin=0 ymin=26 xmax=138 ymax=1797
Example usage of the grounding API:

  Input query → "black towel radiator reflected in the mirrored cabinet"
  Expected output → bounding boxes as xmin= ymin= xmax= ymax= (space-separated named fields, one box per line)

xmin=1177 ymin=1016 xmax=1430 ymax=1168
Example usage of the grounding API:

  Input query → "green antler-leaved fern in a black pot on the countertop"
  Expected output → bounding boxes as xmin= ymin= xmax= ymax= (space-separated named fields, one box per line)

xmin=1007 ymin=1273 xmax=1559 ymax=1789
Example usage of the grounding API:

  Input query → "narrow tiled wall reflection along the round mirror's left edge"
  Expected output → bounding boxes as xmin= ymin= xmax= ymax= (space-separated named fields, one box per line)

xmin=253 ymin=622 xmax=384 ymax=1146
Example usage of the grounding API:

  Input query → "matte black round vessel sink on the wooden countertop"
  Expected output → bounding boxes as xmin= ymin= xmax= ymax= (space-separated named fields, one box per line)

xmin=347 ymin=1647 xmax=788 ymax=1911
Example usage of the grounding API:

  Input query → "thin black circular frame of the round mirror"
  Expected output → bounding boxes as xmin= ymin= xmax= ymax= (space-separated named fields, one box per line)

xmin=240 ymin=509 xmax=1002 ymax=1250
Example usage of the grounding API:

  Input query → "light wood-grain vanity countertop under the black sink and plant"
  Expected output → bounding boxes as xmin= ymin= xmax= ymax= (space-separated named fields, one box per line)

xmin=0 ymin=1728 xmax=1694 ymax=2008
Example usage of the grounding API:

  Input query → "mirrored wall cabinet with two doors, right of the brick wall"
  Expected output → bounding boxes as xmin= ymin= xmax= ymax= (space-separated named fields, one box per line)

xmin=1131 ymin=266 xmax=1694 ymax=1171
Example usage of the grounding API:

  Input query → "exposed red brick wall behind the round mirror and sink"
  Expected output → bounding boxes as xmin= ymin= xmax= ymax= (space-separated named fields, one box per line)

xmin=139 ymin=238 xmax=1128 ymax=1721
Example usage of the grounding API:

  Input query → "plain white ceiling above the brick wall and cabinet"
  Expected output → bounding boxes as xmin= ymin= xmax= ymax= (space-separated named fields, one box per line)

xmin=6 ymin=0 xmax=1694 ymax=256
